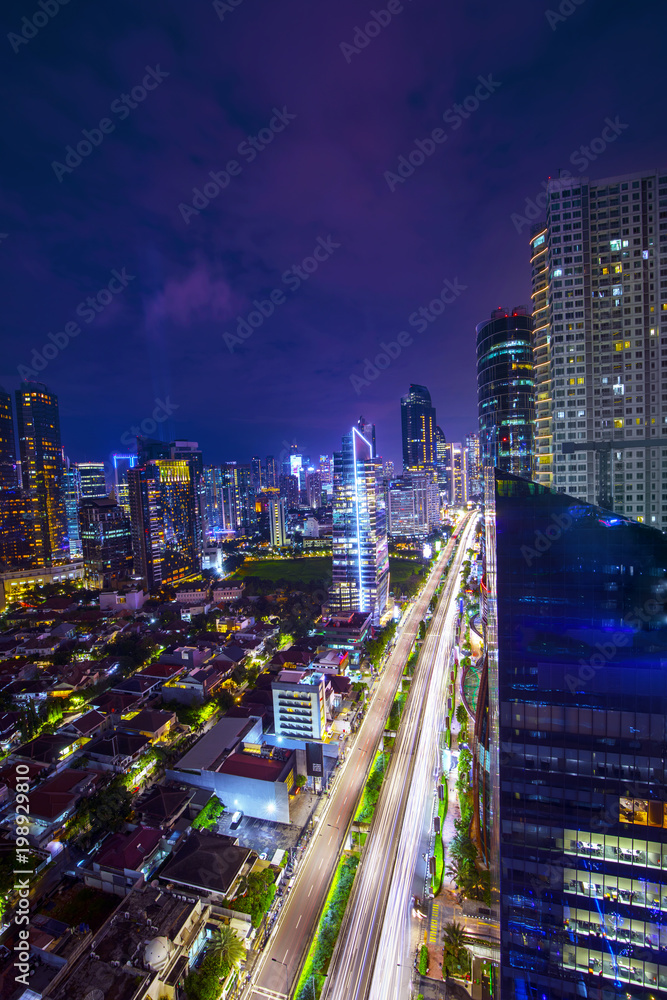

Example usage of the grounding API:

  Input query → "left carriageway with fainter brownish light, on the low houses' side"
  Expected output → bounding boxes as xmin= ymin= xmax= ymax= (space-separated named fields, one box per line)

xmin=244 ymin=524 xmax=468 ymax=1000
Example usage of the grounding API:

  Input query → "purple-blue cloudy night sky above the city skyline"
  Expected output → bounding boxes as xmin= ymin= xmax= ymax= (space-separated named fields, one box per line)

xmin=0 ymin=0 xmax=667 ymax=463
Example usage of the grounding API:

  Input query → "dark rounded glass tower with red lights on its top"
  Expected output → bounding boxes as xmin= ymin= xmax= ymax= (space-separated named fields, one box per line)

xmin=477 ymin=306 xmax=535 ymax=479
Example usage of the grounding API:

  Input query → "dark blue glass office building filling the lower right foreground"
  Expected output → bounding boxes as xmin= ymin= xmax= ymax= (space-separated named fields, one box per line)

xmin=486 ymin=468 xmax=667 ymax=1000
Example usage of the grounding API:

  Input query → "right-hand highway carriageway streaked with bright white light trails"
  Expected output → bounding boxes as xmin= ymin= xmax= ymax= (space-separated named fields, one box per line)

xmin=322 ymin=515 xmax=477 ymax=1000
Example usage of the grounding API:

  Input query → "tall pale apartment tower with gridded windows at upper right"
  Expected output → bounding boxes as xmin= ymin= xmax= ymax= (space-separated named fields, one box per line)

xmin=531 ymin=169 xmax=667 ymax=528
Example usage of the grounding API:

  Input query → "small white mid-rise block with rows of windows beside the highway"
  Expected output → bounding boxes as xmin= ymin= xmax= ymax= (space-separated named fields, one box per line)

xmin=271 ymin=670 xmax=326 ymax=740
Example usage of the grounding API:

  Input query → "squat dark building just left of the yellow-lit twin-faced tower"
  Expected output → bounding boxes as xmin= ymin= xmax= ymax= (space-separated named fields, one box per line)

xmin=79 ymin=497 xmax=132 ymax=590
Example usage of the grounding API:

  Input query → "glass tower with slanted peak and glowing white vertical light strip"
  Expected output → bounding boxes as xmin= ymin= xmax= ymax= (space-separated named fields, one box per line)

xmin=329 ymin=427 xmax=389 ymax=623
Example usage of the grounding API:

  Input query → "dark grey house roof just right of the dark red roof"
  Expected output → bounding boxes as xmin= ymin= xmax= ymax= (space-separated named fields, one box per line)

xmin=160 ymin=830 xmax=252 ymax=894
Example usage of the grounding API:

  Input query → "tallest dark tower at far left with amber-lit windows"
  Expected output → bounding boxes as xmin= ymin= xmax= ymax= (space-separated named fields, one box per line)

xmin=16 ymin=382 xmax=69 ymax=566
